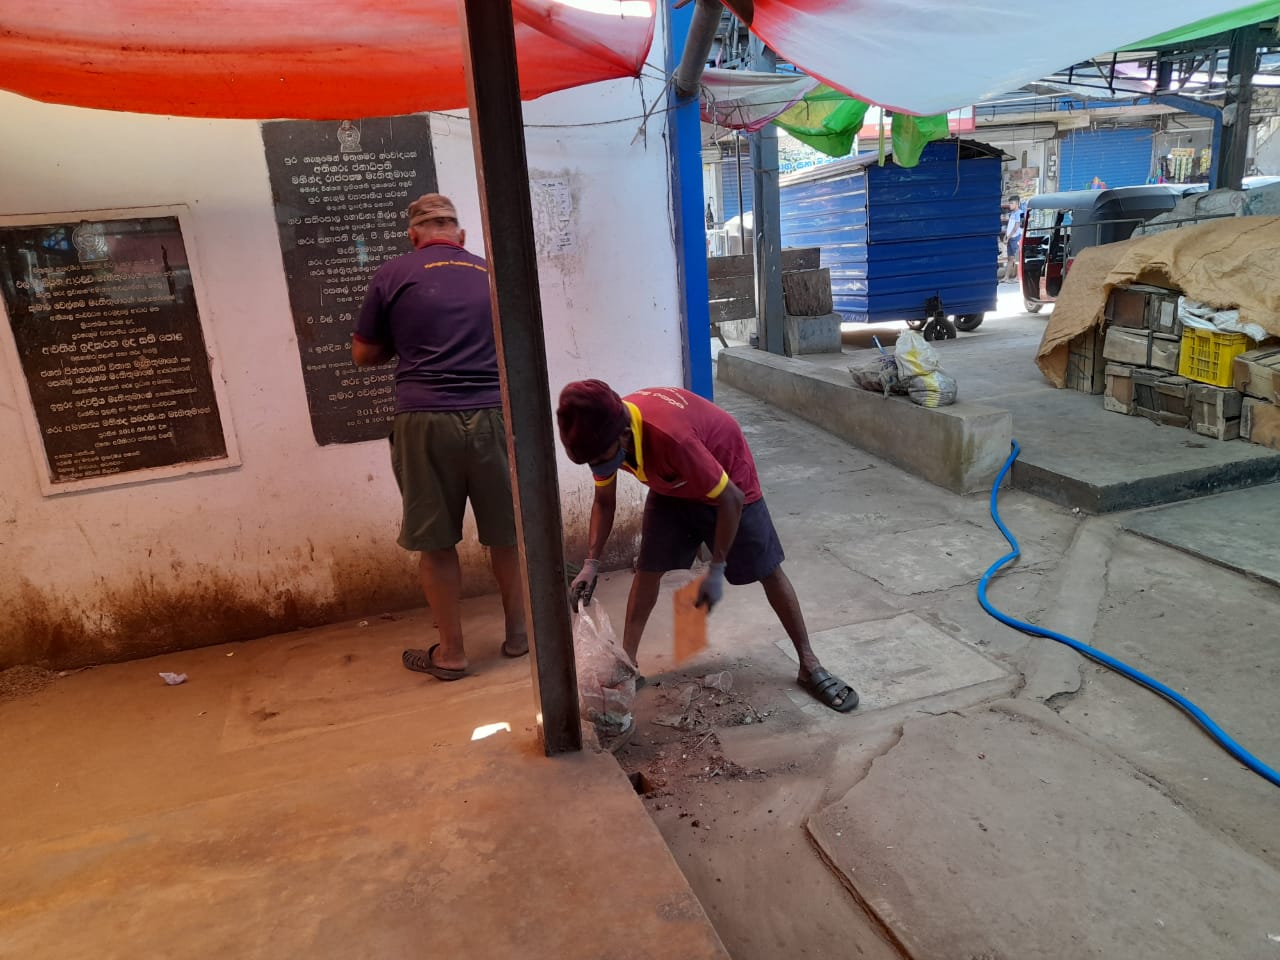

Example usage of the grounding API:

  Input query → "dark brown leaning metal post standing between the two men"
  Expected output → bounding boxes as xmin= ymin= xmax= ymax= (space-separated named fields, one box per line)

xmin=458 ymin=0 xmax=582 ymax=756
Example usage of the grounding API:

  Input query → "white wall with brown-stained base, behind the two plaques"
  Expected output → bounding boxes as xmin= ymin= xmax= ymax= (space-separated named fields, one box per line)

xmin=0 ymin=60 xmax=681 ymax=668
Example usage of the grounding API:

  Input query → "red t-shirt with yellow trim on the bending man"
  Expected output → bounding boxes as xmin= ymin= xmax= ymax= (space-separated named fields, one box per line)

xmin=595 ymin=387 xmax=763 ymax=503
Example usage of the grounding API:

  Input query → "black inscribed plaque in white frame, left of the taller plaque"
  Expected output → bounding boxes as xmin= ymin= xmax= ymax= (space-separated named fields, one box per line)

xmin=0 ymin=216 xmax=227 ymax=484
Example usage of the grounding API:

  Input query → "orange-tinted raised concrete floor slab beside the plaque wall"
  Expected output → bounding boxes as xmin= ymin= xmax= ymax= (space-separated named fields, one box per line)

xmin=0 ymin=609 xmax=726 ymax=960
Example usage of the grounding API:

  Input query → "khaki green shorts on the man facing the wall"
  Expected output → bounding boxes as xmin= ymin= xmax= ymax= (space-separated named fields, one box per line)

xmin=390 ymin=408 xmax=516 ymax=550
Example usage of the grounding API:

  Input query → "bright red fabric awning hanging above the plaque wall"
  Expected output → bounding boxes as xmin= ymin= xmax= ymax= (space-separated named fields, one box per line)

xmin=0 ymin=0 xmax=654 ymax=120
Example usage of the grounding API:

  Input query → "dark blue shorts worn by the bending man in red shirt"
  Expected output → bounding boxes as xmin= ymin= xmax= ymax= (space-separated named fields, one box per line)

xmin=636 ymin=492 xmax=786 ymax=585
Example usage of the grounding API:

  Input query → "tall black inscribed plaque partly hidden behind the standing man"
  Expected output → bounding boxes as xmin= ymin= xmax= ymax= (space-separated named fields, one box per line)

xmin=262 ymin=116 xmax=436 ymax=444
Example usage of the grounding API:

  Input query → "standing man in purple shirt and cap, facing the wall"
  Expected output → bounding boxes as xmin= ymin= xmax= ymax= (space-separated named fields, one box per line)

xmin=351 ymin=193 xmax=529 ymax=680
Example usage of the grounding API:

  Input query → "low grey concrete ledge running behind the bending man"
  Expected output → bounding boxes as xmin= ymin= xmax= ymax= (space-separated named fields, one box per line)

xmin=717 ymin=347 xmax=1014 ymax=494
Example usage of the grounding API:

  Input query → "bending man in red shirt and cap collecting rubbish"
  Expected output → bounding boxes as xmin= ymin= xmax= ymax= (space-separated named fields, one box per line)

xmin=556 ymin=380 xmax=858 ymax=713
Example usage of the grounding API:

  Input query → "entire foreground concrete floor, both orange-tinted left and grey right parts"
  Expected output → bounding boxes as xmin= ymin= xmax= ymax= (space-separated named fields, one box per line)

xmin=10 ymin=299 xmax=1280 ymax=960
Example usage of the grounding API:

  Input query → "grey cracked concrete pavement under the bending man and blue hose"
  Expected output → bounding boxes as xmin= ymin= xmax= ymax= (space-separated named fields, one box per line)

xmin=596 ymin=378 xmax=1280 ymax=960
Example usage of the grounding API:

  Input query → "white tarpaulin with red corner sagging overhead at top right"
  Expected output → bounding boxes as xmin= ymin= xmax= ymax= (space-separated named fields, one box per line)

xmin=747 ymin=0 xmax=1264 ymax=115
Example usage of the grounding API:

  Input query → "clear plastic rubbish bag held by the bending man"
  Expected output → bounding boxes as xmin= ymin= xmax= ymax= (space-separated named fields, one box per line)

xmin=573 ymin=603 xmax=639 ymax=740
